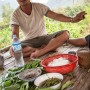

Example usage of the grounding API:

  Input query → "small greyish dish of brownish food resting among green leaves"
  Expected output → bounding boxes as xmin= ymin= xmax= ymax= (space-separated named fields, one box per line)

xmin=18 ymin=68 xmax=42 ymax=82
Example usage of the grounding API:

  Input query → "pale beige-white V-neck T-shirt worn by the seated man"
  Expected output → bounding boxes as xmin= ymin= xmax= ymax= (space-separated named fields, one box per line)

xmin=10 ymin=3 xmax=49 ymax=39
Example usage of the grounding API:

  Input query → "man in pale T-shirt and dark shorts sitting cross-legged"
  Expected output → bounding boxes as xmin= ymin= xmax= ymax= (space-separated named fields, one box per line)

xmin=10 ymin=0 xmax=85 ymax=58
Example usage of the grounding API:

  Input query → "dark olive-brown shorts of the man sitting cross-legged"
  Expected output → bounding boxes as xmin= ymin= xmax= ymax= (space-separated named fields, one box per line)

xmin=22 ymin=30 xmax=65 ymax=48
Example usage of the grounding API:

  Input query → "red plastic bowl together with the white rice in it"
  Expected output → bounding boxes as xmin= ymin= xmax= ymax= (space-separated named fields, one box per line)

xmin=40 ymin=54 xmax=78 ymax=74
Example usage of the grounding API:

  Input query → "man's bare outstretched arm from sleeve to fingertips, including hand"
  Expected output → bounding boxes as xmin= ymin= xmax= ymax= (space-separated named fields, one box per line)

xmin=46 ymin=10 xmax=86 ymax=23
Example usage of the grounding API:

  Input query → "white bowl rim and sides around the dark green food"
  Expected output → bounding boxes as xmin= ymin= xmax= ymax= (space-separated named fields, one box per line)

xmin=34 ymin=73 xmax=63 ymax=90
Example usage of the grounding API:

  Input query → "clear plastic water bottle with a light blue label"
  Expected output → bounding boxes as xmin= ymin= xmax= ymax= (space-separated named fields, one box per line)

xmin=12 ymin=35 xmax=24 ymax=67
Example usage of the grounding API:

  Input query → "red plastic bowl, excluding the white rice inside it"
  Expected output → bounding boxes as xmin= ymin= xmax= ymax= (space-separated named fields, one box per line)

xmin=40 ymin=54 xmax=78 ymax=74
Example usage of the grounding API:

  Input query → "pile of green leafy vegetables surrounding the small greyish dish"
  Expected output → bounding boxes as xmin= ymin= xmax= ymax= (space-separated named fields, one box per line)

xmin=0 ymin=60 xmax=40 ymax=90
